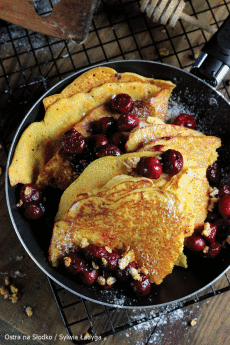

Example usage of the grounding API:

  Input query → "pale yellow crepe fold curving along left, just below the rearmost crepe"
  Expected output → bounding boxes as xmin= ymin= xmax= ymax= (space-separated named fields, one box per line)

xmin=9 ymin=82 xmax=174 ymax=186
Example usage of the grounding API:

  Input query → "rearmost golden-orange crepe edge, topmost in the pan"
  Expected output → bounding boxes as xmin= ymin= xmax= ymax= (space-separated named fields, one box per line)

xmin=43 ymin=67 xmax=175 ymax=110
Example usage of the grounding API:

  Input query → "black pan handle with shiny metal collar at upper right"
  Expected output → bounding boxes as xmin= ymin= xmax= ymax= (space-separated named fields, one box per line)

xmin=190 ymin=15 xmax=230 ymax=87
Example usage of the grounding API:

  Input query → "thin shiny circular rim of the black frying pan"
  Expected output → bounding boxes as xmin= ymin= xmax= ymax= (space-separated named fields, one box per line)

xmin=5 ymin=60 xmax=230 ymax=309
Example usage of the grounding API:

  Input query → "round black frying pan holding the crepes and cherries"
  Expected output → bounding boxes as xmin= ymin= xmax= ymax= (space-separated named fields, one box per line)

xmin=6 ymin=16 xmax=230 ymax=308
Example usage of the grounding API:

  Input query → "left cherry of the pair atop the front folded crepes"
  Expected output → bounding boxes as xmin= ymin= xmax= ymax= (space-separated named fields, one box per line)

xmin=137 ymin=157 xmax=162 ymax=179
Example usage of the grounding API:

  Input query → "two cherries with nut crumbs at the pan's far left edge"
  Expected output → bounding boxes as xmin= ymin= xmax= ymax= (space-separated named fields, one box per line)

xmin=20 ymin=183 xmax=45 ymax=219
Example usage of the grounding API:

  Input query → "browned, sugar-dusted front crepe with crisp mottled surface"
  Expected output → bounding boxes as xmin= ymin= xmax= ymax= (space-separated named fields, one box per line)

xmin=49 ymin=176 xmax=194 ymax=284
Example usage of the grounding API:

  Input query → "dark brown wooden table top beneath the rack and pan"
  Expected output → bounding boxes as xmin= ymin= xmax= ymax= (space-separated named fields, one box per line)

xmin=0 ymin=0 xmax=230 ymax=345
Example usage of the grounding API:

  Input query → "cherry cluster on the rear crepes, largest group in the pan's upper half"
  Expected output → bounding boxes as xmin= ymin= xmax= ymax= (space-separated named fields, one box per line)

xmin=62 ymin=94 xmax=140 ymax=174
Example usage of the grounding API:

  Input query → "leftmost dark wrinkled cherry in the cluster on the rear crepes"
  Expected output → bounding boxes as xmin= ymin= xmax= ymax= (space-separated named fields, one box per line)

xmin=62 ymin=128 xmax=85 ymax=155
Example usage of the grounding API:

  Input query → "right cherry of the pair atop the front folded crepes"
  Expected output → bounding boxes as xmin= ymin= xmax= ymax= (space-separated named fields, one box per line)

xmin=161 ymin=149 xmax=184 ymax=175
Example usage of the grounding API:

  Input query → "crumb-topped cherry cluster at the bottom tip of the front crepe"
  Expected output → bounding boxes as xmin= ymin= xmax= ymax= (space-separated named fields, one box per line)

xmin=64 ymin=244 xmax=151 ymax=297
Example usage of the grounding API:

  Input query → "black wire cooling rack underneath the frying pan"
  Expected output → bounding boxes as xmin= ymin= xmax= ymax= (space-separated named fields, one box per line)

xmin=0 ymin=0 xmax=230 ymax=343
